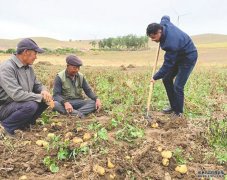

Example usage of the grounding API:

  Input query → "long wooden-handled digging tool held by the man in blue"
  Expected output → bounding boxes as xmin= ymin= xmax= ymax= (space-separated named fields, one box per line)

xmin=145 ymin=44 xmax=160 ymax=122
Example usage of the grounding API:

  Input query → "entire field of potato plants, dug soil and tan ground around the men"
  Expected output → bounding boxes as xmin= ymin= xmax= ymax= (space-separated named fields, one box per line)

xmin=0 ymin=40 xmax=227 ymax=180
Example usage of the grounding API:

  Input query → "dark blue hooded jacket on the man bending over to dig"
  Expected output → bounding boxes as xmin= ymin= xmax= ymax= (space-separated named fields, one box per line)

xmin=153 ymin=16 xmax=197 ymax=80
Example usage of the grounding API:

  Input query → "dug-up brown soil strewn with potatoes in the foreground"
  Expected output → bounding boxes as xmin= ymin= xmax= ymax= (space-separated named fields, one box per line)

xmin=0 ymin=113 xmax=227 ymax=180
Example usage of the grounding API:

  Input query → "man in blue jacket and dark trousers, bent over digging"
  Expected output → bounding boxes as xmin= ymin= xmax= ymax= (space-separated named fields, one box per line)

xmin=147 ymin=16 xmax=198 ymax=116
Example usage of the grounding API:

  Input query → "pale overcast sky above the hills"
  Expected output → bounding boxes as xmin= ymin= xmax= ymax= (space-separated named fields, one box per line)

xmin=0 ymin=0 xmax=227 ymax=40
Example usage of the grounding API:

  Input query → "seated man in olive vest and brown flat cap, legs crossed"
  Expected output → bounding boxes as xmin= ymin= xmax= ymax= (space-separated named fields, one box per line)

xmin=53 ymin=55 xmax=101 ymax=119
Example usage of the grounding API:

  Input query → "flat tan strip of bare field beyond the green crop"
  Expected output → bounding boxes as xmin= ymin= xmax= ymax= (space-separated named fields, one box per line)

xmin=0 ymin=48 xmax=227 ymax=66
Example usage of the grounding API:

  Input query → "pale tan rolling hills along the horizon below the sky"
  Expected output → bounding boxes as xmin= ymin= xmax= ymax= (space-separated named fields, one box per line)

xmin=0 ymin=34 xmax=227 ymax=50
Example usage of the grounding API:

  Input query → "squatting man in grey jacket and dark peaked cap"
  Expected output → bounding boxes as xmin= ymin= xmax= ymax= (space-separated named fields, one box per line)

xmin=0 ymin=38 xmax=52 ymax=135
